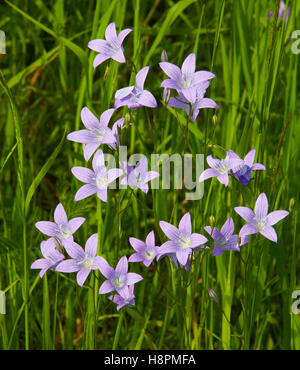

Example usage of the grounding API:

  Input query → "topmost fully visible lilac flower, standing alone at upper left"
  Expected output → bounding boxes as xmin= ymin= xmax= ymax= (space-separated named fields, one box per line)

xmin=88 ymin=22 xmax=132 ymax=68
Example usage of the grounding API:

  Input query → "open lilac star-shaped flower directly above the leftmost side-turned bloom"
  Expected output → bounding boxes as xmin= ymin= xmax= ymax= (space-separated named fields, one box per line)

xmin=35 ymin=203 xmax=85 ymax=247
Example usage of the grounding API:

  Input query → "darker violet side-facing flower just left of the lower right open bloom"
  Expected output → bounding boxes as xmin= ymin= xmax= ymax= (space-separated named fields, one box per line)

xmin=204 ymin=217 xmax=250 ymax=256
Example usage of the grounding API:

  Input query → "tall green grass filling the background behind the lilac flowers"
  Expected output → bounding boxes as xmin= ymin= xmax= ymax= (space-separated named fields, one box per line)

xmin=0 ymin=0 xmax=300 ymax=349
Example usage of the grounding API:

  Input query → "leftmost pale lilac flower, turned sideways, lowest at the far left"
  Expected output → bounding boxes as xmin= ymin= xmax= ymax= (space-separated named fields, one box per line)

xmin=30 ymin=238 xmax=65 ymax=278
